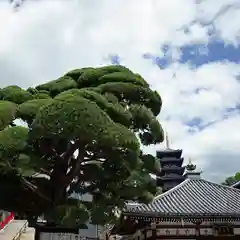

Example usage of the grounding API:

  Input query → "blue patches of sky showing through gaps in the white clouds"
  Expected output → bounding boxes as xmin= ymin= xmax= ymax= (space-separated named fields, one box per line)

xmin=109 ymin=39 xmax=240 ymax=137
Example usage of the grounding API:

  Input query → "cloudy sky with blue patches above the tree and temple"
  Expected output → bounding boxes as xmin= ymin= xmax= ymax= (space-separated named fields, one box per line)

xmin=0 ymin=0 xmax=240 ymax=182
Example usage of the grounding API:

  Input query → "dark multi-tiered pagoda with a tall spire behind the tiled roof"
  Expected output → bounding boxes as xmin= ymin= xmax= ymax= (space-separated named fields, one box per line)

xmin=157 ymin=132 xmax=185 ymax=192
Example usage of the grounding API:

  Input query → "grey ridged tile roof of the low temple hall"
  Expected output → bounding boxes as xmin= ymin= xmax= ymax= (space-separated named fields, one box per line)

xmin=125 ymin=179 xmax=240 ymax=217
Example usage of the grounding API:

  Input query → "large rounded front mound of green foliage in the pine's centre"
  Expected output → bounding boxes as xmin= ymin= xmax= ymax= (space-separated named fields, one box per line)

xmin=30 ymin=95 xmax=139 ymax=151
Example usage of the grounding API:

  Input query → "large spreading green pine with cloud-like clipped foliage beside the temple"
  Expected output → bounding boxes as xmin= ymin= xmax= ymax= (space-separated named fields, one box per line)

xmin=0 ymin=65 xmax=164 ymax=225
